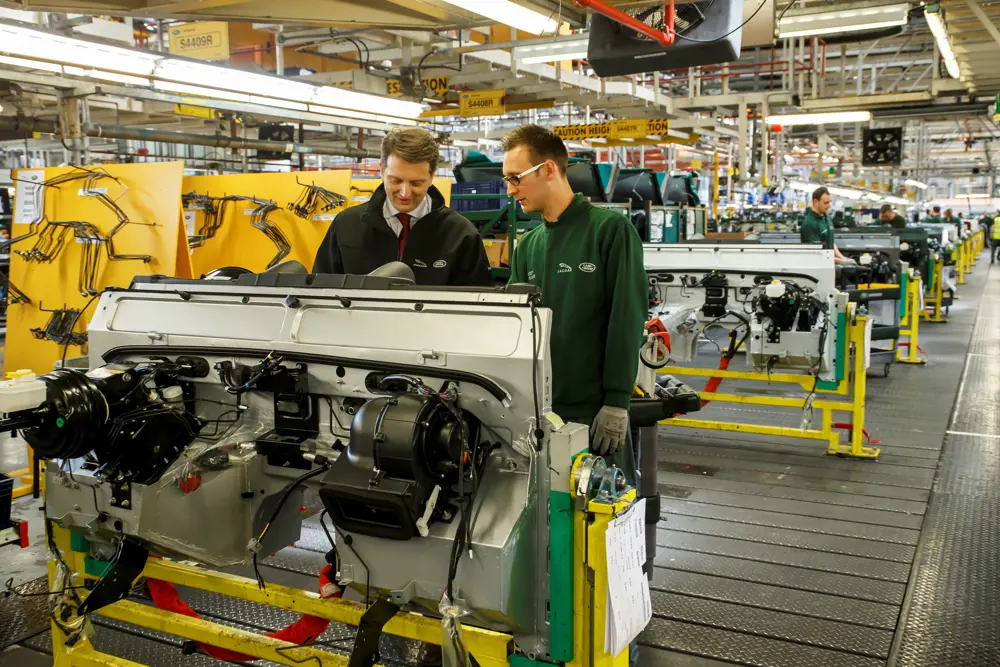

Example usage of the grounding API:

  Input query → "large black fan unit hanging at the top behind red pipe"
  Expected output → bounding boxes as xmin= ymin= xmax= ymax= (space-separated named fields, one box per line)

xmin=581 ymin=0 xmax=743 ymax=77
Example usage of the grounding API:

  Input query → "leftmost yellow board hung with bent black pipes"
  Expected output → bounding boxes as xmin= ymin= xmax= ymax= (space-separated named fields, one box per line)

xmin=5 ymin=162 xmax=190 ymax=374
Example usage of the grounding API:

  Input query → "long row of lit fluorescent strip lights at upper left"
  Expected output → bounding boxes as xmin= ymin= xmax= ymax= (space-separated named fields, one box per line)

xmin=0 ymin=23 xmax=424 ymax=124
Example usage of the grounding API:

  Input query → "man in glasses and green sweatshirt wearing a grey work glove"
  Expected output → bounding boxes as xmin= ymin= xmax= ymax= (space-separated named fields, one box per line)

xmin=503 ymin=125 xmax=649 ymax=484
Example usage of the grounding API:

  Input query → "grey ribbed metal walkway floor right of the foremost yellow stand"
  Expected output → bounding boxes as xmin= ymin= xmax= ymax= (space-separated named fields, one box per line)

xmin=640 ymin=253 xmax=1000 ymax=667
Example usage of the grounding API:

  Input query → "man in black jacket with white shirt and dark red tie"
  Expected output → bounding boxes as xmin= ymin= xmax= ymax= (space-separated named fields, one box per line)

xmin=313 ymin=128 xmax=493 ymax=286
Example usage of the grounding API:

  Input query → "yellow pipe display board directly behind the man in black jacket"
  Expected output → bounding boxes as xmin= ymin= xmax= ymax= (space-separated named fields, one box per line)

xmin=182 ymin=169 xmax=351 ymax=277
